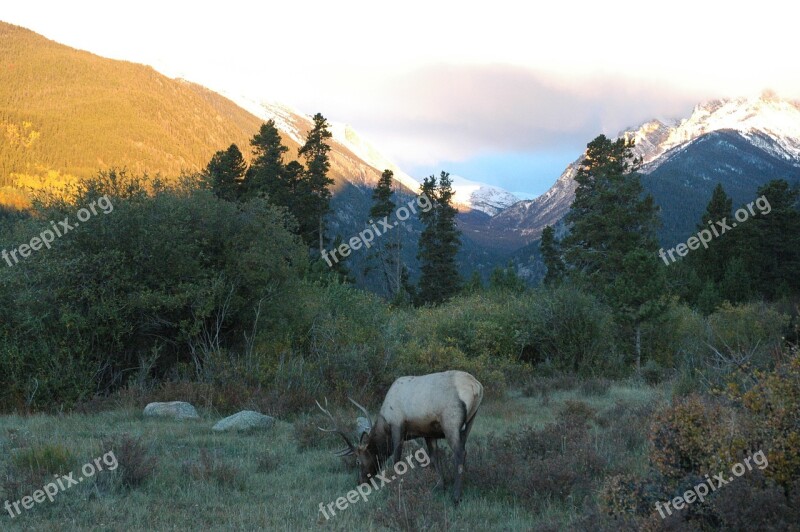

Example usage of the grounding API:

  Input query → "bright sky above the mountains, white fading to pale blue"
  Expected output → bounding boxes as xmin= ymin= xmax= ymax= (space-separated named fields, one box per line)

xmin=0 ymin=0 xmax=800 ymax=196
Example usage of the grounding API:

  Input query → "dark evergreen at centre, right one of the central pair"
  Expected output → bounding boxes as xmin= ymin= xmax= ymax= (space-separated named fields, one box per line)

xmin=417 ymin=172 xmax=461 ymax=304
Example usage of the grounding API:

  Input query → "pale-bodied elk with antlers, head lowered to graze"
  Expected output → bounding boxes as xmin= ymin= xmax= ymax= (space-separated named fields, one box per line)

xmin=317 ymin=370 xmax=483 ymax=504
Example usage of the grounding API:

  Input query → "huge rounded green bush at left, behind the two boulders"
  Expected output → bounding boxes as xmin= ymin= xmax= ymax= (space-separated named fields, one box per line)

xmin=0 ymin=171 xmax=306 ymax=409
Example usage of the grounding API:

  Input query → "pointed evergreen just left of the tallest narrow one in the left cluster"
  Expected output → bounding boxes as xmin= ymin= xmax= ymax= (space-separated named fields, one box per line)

xmin=244 ymin=120 xmax=296 ymax=202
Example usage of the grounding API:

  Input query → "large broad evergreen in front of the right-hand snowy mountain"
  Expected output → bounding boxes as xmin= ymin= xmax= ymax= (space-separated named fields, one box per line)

xmin=562 ymin=135 xmax=666 ymax=368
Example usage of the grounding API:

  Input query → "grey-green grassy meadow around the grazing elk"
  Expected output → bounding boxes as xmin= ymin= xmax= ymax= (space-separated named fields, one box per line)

xmin=0 ymin=382 xmax=666 ymax=530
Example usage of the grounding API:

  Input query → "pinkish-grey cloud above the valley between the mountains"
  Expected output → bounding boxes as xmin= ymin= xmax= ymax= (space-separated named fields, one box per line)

xmin=316 ymin=65 xmax=705 ymax=164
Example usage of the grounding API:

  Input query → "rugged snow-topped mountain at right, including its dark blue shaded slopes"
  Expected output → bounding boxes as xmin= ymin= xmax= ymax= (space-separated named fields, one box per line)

xmin=484 ymin=92 xmax=800 ymax=247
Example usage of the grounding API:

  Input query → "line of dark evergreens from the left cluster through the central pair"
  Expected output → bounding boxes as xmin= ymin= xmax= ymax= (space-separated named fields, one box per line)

xmin=202 ymin=113 xmax=462 ymax=305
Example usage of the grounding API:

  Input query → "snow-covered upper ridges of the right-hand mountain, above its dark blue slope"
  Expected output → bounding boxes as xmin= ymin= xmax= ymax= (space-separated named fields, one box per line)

xmin=488 ymin=92 xmax=800 ymax=245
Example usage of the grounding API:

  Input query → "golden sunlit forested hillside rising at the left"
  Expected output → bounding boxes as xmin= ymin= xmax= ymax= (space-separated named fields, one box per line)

xmin=0 ymin=22 xmax=398 ymax=210
